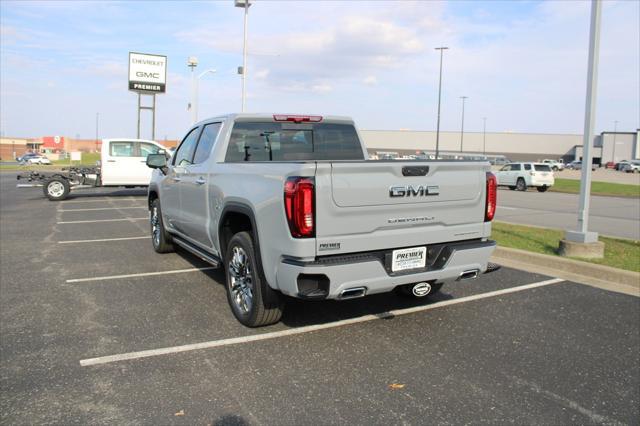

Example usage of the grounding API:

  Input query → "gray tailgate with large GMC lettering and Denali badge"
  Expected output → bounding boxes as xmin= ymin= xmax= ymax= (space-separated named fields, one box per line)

xmin=316 ymin=161 xmax=489 ymax=255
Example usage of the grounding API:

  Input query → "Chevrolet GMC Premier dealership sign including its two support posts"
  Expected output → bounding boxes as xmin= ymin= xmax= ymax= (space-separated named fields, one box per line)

xmin=129 ymin=52 xmax=167 ymax=139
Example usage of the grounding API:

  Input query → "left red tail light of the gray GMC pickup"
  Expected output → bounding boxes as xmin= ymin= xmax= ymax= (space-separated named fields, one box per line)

xmin=284 ymin=177 xmax=315 ymax=238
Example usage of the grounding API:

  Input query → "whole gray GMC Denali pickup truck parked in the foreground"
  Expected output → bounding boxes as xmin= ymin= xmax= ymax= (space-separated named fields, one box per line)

xmin=147 ymin=114 xmax=496 ymax=327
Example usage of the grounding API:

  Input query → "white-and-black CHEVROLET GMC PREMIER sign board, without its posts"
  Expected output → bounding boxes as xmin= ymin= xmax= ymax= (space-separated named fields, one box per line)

xmin=129 ymin=52 xmax=167 ymax=93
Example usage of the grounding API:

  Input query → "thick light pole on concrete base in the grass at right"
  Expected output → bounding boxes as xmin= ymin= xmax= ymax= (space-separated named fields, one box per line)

xmin=560 ymin=0 xmax=604 ymax=258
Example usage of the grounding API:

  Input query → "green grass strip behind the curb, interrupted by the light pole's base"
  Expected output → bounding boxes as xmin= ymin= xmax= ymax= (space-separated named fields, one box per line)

xmin=491 ymin=222 xmax=640 ymax=272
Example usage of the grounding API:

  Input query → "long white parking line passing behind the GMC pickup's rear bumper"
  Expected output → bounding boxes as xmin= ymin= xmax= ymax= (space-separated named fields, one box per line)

xmin=80 ymin=278 xmax=564 ymax=367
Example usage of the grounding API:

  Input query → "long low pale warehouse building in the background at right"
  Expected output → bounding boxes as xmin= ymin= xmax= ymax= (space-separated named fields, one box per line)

xmin=360 ymin=130 xmax=640 ymax=164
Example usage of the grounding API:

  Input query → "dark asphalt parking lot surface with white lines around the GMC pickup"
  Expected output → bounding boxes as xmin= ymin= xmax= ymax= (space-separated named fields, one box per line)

xmin=0 ymin=173 xmax=640 ymax=425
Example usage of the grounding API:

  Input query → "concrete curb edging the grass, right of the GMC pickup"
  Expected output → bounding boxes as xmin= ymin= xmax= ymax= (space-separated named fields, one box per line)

xmin=492 ymin=247 xmax=640 ymax=296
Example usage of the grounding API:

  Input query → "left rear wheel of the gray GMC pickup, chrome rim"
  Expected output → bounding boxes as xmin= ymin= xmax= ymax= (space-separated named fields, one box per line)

xmin=224 ymin=232 xmax=284 ymax=327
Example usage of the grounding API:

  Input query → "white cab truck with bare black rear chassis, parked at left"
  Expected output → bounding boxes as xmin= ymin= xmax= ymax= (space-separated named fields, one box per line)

xmin=17 ymin=138 xmax=166 ymax=201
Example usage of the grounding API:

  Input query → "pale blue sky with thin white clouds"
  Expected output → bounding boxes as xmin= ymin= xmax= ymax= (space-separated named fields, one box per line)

xmin=0 ymin=0 xmax=640 ymax=139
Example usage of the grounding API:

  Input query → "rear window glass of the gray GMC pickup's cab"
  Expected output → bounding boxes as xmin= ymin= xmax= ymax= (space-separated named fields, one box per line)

xmin=226 ymin=122 xmax=364 ymax=162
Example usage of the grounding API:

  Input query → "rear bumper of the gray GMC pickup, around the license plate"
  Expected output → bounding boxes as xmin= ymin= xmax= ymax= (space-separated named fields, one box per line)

xmin=276 ymin=241 xmax=496 ymax=299
